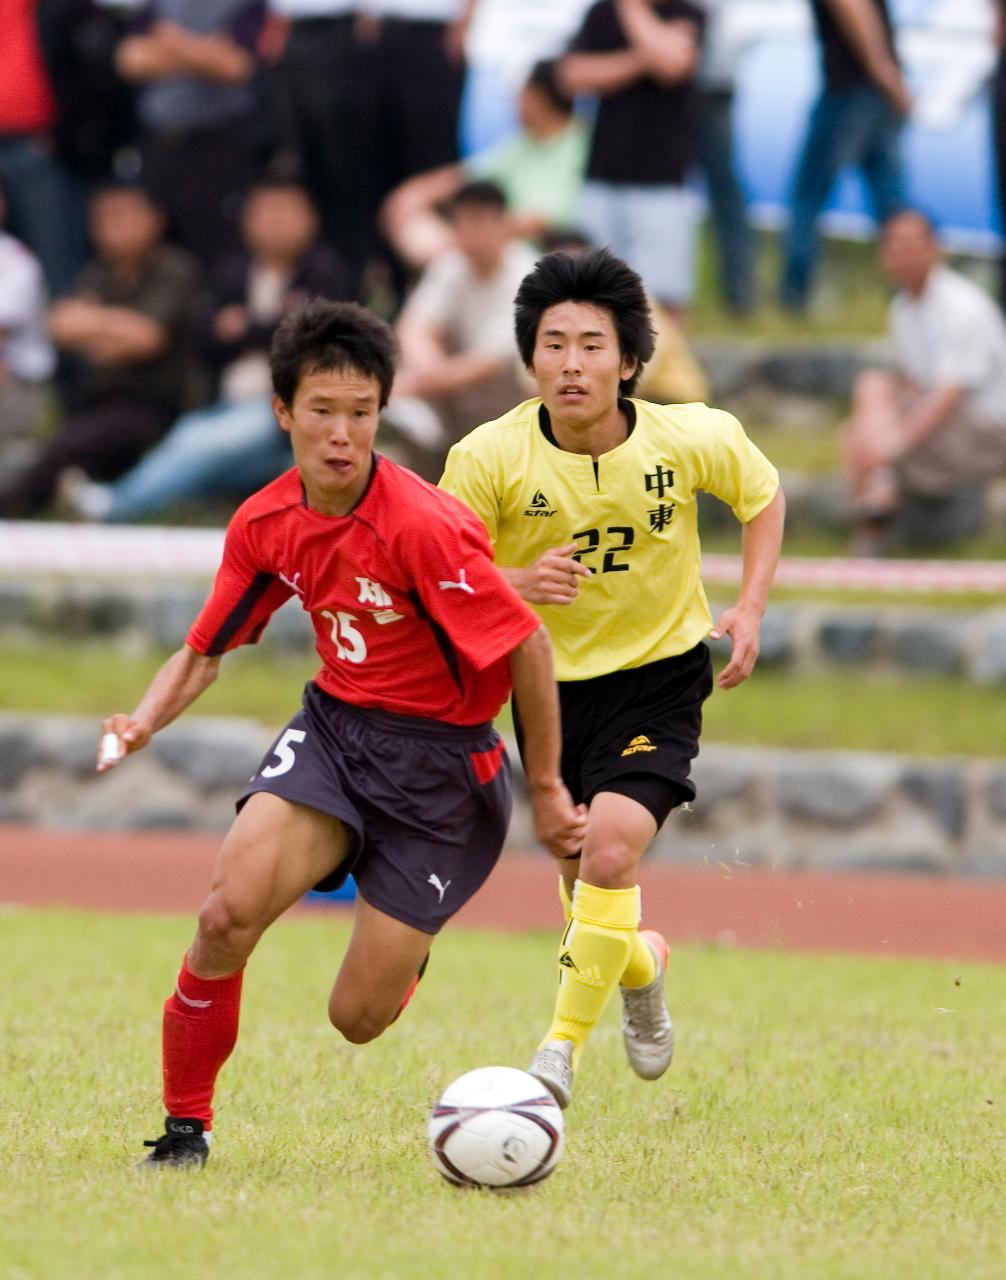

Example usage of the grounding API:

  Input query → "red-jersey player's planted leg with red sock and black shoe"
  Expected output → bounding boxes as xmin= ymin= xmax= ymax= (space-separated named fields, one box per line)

xmin=147 ymin=792 xmax=348 ymax=1167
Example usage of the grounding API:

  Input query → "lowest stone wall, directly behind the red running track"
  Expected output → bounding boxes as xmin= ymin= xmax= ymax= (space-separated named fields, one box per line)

xmin=7 ymin=714 xmax=1006 ymax=876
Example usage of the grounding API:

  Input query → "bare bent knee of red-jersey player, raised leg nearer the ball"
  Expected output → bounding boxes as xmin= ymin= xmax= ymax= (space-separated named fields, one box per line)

xmin=329 ymin=897 xmax=433 ymax=1044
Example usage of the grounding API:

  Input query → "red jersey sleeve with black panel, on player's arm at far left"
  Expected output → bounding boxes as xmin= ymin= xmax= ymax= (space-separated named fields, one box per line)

xmin=186 ymin=520 xmax=293 ymax=658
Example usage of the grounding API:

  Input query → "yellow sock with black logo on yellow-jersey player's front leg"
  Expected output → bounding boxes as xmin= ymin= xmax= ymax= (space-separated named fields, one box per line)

xmin=543 ymin=881 xmax=639 ymax=1066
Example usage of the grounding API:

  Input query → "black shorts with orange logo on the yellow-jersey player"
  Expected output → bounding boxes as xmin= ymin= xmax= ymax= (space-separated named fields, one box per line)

xmin=513 ymin=644 xmax=713 ymax=827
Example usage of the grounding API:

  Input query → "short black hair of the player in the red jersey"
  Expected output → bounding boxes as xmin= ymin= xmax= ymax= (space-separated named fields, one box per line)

xmin=269 ymin=298 xmax=398 ymax=408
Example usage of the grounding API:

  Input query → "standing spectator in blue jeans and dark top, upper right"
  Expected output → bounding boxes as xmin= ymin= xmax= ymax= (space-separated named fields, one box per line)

xmin=779 ymin=0 xmax=911 ymax=311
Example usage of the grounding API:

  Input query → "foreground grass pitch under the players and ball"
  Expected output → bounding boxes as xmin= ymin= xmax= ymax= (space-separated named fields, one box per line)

xmin=0 ymin=911 xmax=1006 ymax=1280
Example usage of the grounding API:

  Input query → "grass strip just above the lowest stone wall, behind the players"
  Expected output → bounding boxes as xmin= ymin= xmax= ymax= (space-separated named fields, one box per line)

xmin=0 ymin=645 xmax=1006 ymax=756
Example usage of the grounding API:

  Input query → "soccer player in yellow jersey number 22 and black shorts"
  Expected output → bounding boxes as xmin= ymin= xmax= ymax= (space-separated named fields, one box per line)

xmin=442 ymin=250 xmax=785 ymax=1107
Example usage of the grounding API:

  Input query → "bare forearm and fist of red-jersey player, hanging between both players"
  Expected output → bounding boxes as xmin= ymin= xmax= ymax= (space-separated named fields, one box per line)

xmin=509 ymin=627 xmax=586 ymax=858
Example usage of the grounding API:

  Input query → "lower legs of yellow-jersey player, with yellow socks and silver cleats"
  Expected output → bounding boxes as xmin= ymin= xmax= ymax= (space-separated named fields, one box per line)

xmin=530 ymin=791 xmax=673 ymax=1106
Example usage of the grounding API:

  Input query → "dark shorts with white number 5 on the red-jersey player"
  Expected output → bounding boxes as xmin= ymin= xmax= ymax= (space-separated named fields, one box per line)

xmin=238 ymin=681 xmax=512 ymax=933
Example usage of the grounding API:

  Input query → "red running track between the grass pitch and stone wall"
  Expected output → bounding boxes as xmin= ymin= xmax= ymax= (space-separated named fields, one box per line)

xmin=0 ymin=827 xmax=1006 ymax=963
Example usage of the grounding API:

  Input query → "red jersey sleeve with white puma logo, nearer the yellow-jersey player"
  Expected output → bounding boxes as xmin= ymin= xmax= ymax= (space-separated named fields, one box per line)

xmin=401 ymin=508 xmax=541 ymax=671
